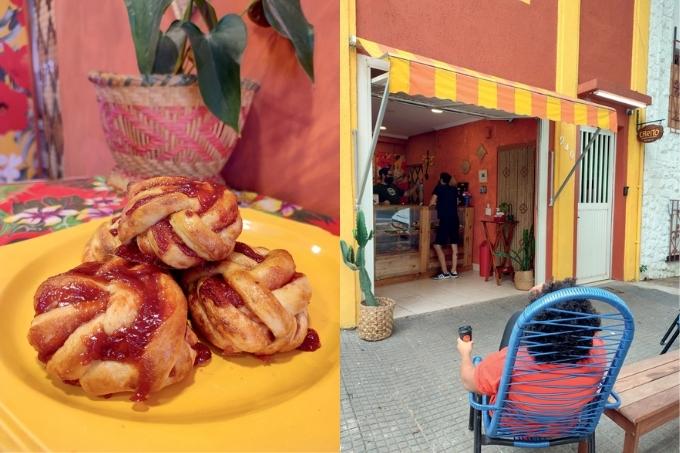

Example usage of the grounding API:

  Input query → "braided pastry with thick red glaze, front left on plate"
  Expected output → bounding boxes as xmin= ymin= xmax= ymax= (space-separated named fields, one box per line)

xmin=28 ymin=257 xmax=205 ymax=401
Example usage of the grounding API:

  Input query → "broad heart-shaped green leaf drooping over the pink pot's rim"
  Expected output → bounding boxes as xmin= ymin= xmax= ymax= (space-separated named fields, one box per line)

xmin=182 ymin=14 xmax=247 ymax=132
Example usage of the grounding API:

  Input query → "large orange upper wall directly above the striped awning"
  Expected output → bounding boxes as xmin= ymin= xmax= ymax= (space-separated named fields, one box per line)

xmin=357 ymin=0 xmax=557 ymax=89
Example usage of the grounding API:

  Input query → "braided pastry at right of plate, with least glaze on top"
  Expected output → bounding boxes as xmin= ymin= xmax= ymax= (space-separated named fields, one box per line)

xmin=184 ymin=242 xmax=312 ymax=355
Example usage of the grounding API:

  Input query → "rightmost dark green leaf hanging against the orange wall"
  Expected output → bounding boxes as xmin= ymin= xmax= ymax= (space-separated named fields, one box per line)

xmin=262 ymin=0 xmax=314 ymax=81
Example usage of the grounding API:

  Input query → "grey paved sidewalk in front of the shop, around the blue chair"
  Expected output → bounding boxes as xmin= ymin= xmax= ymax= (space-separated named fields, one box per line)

xmin=341 ymin=282 xmax=679 ymax=453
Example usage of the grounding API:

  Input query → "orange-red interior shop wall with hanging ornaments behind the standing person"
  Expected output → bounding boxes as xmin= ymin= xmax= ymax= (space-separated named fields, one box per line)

xmin=407 ymin=119 xmax=538 ymax=263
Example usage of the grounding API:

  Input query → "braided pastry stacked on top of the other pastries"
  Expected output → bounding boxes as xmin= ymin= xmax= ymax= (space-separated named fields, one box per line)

xmin=118 ymin=176 xmax=242 ymax=269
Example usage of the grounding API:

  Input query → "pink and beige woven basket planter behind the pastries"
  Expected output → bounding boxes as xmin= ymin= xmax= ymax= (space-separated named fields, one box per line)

xmin=88 ymin=72 xmax=259 ymax=190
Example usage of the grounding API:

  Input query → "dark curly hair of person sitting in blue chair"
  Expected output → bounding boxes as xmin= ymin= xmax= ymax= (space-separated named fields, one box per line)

xmin=527 ymin=278 xmax=600 ymax=363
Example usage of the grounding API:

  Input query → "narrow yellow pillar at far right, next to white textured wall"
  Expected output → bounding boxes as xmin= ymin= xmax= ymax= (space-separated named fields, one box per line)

xmin=623 ymin=0 xmax=650 ymax=281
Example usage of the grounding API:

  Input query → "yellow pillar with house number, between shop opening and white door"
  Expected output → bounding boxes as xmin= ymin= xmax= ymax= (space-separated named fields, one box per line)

xmin=552 ymin=0 xmax=581 ymax=279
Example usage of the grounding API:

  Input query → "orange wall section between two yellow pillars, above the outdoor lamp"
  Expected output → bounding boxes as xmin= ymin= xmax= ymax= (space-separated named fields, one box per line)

xmin=578 ymin=0 xmax=636 ymax=88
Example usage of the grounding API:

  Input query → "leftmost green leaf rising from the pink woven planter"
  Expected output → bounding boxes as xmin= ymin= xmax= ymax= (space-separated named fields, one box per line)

xmin=125 ymin=0 xmax=172 ymax=74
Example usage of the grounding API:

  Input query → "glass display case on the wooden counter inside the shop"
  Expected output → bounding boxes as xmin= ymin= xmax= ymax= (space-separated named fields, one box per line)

xmin=373 ymin=205 xmax=420 ymax=256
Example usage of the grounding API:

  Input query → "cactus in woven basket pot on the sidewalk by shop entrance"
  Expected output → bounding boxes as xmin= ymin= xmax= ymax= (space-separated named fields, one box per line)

xmin=340 ymin=211 xmax=395 ymax=341
